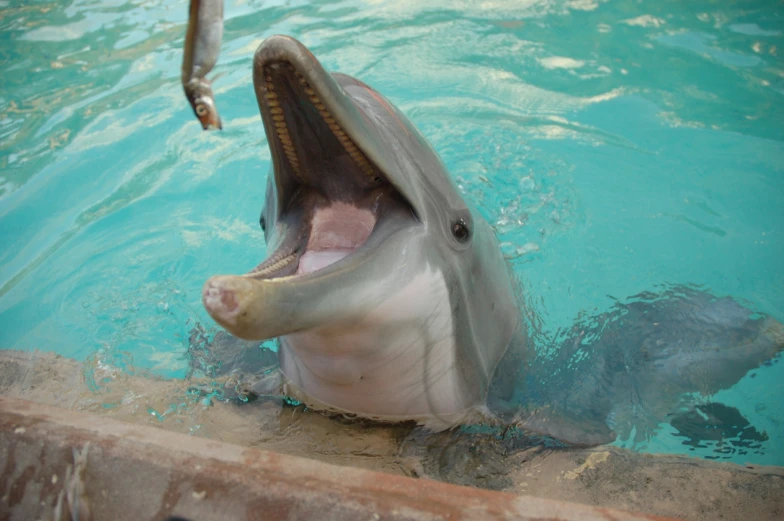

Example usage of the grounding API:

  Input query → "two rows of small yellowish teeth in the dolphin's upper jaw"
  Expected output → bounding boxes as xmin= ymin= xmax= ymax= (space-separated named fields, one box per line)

xmin=266 ymin=65 xmax=375 ymax=178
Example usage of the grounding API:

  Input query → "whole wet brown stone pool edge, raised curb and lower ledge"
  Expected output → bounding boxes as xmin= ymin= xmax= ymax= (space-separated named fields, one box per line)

xmin=0 ymin=350 xmax=784 ymax=521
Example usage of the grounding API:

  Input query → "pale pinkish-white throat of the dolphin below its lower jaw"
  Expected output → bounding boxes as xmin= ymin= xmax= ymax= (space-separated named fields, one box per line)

xmin=280 ymin=267 xmax=468 ymax=424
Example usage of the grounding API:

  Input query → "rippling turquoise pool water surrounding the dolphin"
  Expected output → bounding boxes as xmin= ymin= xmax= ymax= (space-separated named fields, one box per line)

xmin=0 ymin=0 xmax=784 ymax=465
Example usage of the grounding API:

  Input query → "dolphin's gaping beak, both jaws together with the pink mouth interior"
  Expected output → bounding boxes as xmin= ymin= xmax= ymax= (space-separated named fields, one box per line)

xmin=202 ymin=36 xmax=422 ymax=339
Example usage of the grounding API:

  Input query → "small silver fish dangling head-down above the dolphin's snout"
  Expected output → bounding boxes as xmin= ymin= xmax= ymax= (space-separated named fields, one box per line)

xmin=182 ymin=0 xmax=223 ymax=130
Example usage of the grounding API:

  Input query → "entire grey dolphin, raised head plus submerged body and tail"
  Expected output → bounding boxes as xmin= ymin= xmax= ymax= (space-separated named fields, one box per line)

xmin=202 ymin=36 xmax=784 ymax=445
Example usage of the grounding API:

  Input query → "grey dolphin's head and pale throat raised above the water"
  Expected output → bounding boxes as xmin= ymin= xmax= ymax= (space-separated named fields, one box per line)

xmin=202 ymin=36 xmax=519 ymax=423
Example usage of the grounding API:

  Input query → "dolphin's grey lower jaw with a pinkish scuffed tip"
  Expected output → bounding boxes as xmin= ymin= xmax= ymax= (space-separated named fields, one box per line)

xmin=202 ymin=209 xmax=422 ymax=340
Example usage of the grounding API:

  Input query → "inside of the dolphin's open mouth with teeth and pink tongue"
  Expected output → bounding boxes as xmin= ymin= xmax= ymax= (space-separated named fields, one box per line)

xmin=248 ymin=55 xmax=414 ymax=279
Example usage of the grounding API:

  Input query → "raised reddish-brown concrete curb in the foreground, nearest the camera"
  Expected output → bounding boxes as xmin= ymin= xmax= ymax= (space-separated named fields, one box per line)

xmin=0 ymin=396 xmax=680 ymax=521
